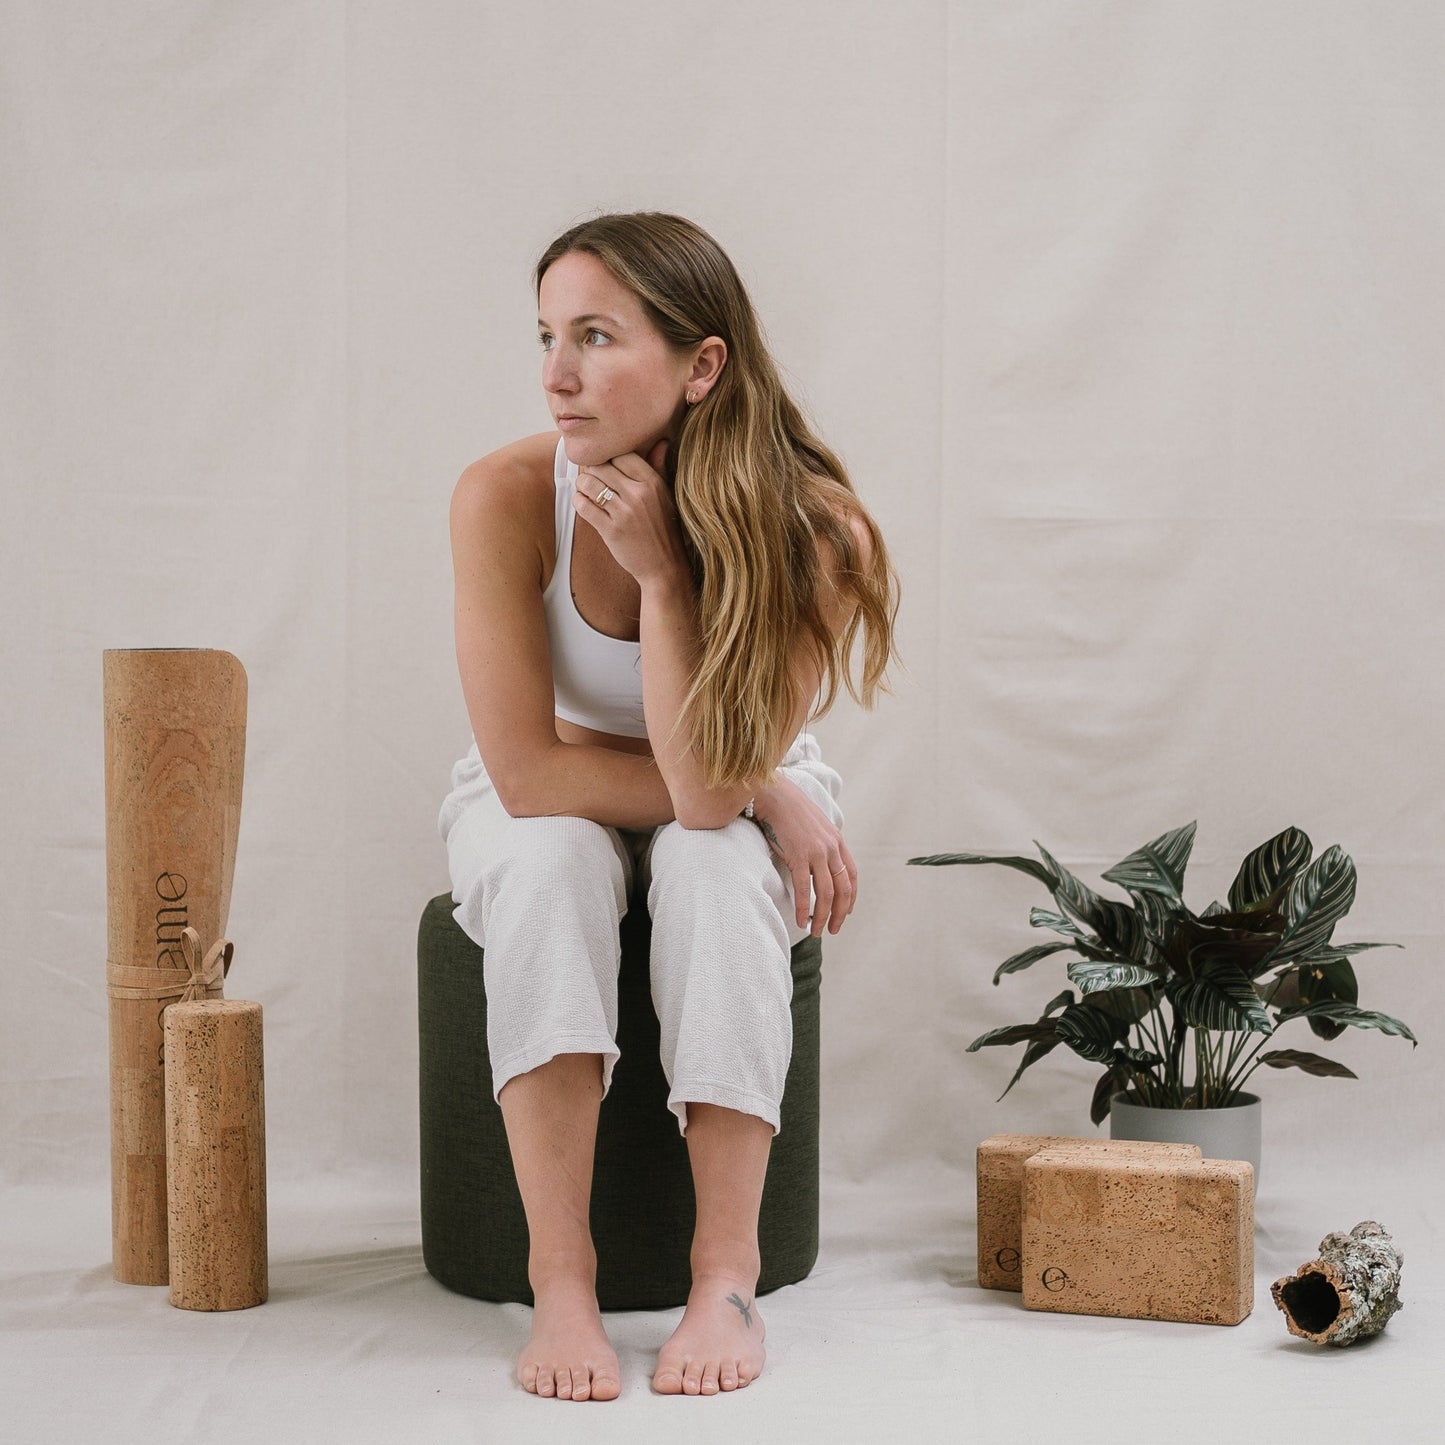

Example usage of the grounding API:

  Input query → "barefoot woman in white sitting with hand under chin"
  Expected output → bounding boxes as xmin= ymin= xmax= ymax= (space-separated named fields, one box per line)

xmin=441 ymin=212 xmax=896 ymax=1400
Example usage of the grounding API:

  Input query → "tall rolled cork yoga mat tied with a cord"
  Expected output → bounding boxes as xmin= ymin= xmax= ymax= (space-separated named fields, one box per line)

xmin=104 ymin=649 xmax=246 ymax=1285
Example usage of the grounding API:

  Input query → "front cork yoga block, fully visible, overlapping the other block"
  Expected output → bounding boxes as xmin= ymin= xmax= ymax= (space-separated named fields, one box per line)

xmin=1023 ymin=1149 xmax=1254 ymax=1325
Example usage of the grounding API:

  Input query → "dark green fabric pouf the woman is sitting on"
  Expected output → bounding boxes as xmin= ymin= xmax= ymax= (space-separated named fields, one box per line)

xmin=416 ymin=893 xmax=822 ymax=1309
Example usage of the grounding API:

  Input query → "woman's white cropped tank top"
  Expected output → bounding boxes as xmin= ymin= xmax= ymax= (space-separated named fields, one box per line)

xmin=542 ymin=442 xmax=647 ymax=737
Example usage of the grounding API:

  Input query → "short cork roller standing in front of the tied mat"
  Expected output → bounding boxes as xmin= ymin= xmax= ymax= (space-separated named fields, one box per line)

xmin=165 ymin=998 xmax=267 ymax=1309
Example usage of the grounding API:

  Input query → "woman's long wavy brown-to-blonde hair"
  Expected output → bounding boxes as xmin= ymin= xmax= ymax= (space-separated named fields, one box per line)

xmin=535 ymin=211 xmax=899 ymax=788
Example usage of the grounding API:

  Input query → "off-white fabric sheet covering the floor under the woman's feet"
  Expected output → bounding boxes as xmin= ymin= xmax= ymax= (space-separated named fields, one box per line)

xmin=0 ymin=1165 xmax=1445 ymax=1445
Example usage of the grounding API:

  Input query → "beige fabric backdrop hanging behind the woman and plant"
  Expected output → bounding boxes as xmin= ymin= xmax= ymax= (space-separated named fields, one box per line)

xmin=0 ymin=0 xmax=1445 ymax=1433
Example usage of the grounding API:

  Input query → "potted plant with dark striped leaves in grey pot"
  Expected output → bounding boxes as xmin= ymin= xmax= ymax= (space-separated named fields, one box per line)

xmin=907 ymin=822 xmax=1418 ymax=1168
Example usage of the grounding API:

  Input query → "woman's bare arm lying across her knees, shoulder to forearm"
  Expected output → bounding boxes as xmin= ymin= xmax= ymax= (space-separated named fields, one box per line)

xmin=451 ymin=432 xmax=673 ymax=828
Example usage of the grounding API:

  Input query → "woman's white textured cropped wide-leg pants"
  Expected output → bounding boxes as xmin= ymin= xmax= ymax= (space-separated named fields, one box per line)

xmin=438 ymin=733 xmax=842 ymax=1133
